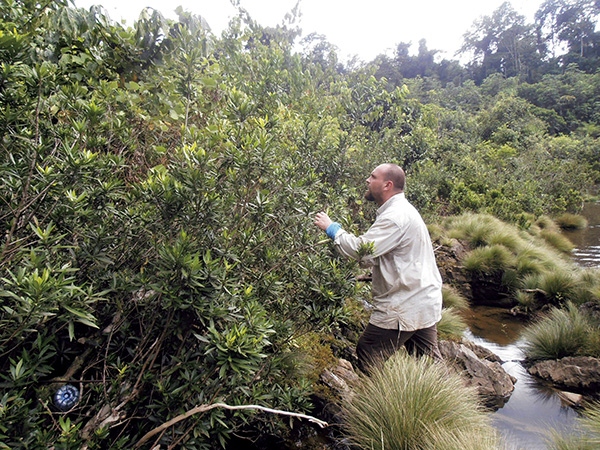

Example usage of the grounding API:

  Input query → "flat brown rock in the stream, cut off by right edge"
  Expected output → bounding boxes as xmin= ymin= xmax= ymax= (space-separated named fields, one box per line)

xmin=527 ymin=356 xmax=600 ymax=393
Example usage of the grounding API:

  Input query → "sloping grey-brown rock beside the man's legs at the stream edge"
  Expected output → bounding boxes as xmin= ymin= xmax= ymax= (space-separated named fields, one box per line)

xmin=439 ymin=341 xmax=517 ymax=409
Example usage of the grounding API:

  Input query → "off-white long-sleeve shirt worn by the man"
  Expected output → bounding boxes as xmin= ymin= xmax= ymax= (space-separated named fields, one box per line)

xmin=334 ymin=193 xmax=442 ymax=331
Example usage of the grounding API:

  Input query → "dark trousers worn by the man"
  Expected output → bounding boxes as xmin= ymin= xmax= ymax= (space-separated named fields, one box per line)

xmin=356 ymin=324 xmax=442 ymax=373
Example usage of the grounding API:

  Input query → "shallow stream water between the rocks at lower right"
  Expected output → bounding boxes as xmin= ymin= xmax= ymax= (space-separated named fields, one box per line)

xmin=465 ymin=306 xmax=578 ymax=450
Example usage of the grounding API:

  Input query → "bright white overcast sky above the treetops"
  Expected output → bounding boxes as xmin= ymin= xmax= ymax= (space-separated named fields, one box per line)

xmin=74 ymin=0 xmax=543 ymax=62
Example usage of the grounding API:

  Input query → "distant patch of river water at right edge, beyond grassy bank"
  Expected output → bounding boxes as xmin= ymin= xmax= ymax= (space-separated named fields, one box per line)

xmin=564 ymin=202 xmax=600 ymax=267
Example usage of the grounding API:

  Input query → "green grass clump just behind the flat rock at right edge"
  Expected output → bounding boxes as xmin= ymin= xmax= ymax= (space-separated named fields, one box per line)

xmin=523 ymin=303 xmax=598 ymax=361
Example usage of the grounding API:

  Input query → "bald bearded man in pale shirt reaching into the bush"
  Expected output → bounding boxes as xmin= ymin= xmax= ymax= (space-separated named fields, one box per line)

xmin=314 ymin=164 xmax=442 ymax=372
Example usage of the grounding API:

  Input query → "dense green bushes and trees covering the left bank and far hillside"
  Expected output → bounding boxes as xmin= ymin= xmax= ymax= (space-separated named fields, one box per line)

xmin=0 ymin=0 xmax=600 ymax=449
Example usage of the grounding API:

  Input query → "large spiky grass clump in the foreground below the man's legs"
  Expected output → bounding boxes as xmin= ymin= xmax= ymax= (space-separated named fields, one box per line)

xmin=343 ymin=352 xmax=499 ymax=450
